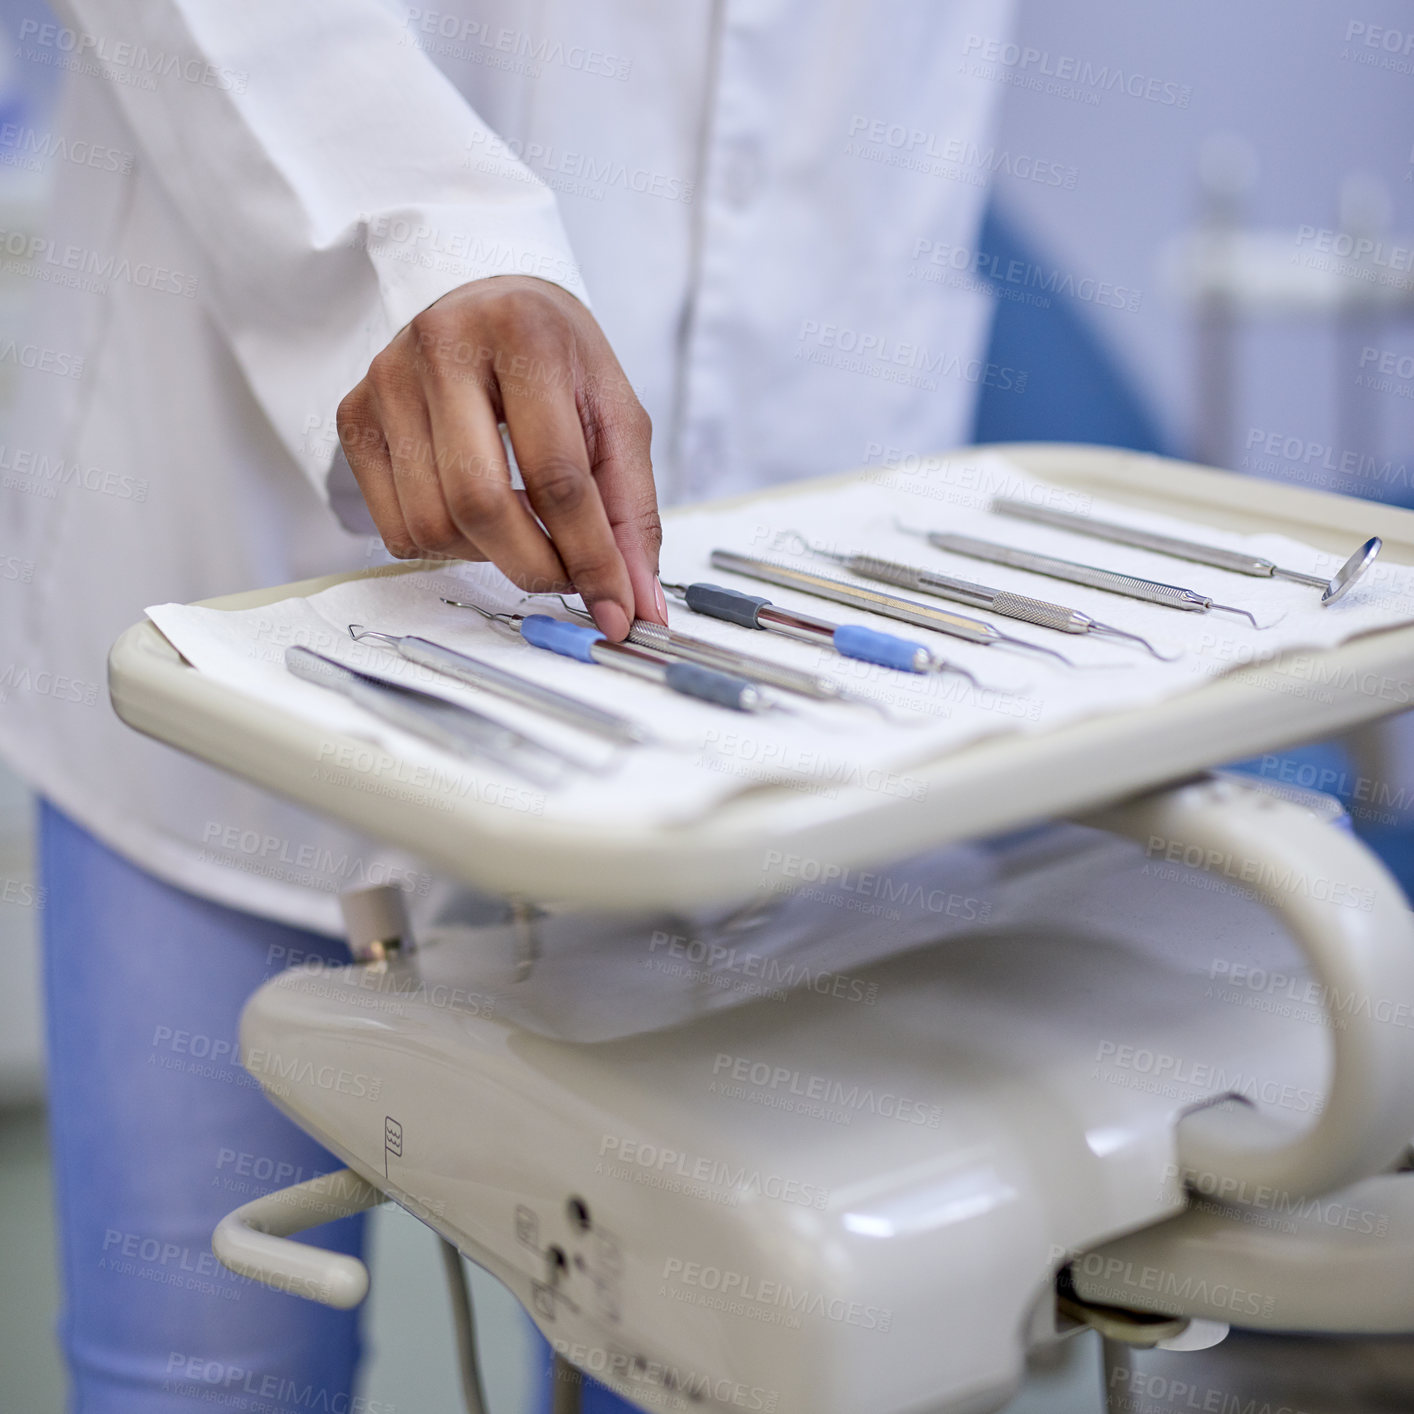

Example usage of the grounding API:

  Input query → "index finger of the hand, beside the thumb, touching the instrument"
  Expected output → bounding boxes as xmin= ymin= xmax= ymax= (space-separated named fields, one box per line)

xmin=498 ymin=339 xmax=636 ymax=639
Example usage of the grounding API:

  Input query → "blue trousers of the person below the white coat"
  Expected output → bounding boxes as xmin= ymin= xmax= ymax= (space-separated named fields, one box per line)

xmin=38 ymin=805 xmax=629 ymax=1414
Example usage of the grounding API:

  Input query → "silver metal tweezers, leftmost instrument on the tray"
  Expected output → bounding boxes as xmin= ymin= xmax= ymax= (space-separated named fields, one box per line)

xmin=284 ymin=646 xmax=571 ymax=785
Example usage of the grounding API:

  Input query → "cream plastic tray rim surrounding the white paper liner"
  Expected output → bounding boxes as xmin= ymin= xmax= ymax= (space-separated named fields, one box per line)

xmin=109 ymin=444 xmax=1414 ymax=908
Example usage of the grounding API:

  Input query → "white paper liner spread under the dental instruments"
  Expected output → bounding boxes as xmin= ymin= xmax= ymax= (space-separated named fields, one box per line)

xmin=147 ymin=451 xmax=1414 ymax=826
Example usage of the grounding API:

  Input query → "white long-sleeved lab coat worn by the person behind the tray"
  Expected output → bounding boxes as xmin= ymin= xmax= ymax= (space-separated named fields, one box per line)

xmin=0 ymin=0 xmax=1008 ymax=929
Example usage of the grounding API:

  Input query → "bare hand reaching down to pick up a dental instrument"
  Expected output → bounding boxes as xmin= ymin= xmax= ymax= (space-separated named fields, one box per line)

xmin=338 ymin=276 xmax=667 ymax=639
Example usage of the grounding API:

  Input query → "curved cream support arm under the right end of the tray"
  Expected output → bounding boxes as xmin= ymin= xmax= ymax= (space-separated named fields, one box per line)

xmin=1083 ymin=779 xmax=1414 ymax=1198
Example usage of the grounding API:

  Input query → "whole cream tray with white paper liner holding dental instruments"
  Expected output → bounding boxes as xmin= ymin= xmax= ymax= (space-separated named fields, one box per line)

xmin=109 ymin=444 xmax=1414 ymax=909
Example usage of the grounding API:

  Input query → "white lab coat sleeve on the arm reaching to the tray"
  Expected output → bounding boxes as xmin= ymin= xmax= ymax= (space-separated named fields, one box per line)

xmin=42 ymin=0 xmax=587 ymax=529
